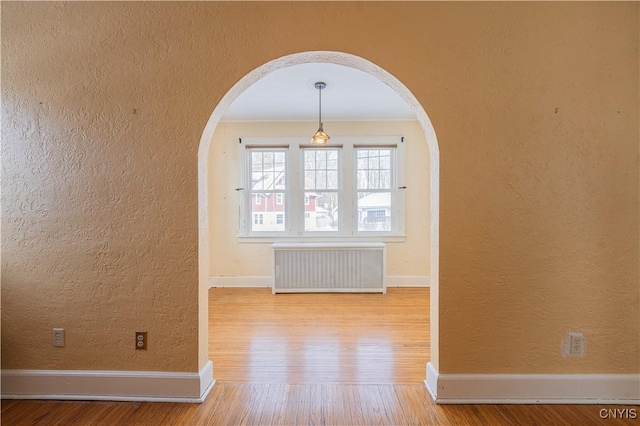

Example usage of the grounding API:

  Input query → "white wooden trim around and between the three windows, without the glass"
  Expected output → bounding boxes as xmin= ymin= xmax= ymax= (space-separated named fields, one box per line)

xmin=238 ymin=136 xmax=406 ymax=243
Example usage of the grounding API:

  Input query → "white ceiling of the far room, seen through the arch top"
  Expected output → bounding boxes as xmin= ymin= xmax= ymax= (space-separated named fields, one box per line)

xmin=222 ymin=63 xmax=416 ymax=121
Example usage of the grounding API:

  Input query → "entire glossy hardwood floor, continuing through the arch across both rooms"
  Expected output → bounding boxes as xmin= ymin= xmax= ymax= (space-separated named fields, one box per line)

xmin=1 ymin=289 xmax=637 ymax=425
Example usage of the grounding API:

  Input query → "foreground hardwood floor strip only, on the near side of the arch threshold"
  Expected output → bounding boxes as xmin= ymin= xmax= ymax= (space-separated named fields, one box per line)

xmin=2 ymin=383 xmax=637 ymax=426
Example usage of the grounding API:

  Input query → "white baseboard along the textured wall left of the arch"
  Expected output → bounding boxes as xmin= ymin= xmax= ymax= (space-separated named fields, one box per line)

xmin=2 ymin=361 xmax=215 ymax=403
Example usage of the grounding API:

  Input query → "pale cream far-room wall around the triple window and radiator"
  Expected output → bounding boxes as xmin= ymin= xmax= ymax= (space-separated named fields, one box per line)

xmin=209 ymin=121 xmax=430 ymax=277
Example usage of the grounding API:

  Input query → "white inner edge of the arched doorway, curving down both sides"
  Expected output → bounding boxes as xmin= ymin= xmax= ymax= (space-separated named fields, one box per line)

xmin=198 ymin=51 xmax=440 ymax=386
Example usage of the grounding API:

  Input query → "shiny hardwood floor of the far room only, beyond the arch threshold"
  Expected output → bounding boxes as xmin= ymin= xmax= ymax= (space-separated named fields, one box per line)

xmin=209 ymin=288 xmax=429 ymax=384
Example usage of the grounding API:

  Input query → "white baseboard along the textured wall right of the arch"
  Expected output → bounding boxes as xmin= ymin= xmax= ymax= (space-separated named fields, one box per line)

xmin=425 ymin=363 xmax=640 ymax=405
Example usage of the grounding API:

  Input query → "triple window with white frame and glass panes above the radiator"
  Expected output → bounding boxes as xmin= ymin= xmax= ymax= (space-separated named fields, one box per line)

xmin=239 ymin=136 xmax=404 ymax=241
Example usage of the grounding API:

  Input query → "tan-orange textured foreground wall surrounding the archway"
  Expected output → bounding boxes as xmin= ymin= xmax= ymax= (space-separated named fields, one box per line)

xmin=2 ymin=2 xmax=640 ymax=373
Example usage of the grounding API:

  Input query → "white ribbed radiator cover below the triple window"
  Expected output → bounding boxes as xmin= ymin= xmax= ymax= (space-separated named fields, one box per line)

xmin=271 ymin=243 xmax=386 ymax=294
